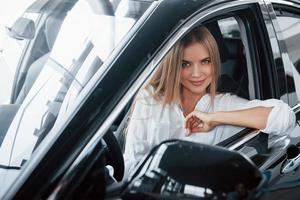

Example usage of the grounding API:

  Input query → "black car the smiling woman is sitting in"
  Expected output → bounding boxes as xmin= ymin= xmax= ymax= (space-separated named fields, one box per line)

xmin=0 ymin=0 xmax=300 ymax=199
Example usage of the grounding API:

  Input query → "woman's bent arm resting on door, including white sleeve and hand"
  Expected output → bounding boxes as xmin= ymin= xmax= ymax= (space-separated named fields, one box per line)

xmin=186 ymin=94 xmax=296 ymax=135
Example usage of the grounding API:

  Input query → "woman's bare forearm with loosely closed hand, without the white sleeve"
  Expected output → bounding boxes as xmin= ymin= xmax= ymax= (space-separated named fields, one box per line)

xmin=186 ymin=107 xmax=272 ymax=135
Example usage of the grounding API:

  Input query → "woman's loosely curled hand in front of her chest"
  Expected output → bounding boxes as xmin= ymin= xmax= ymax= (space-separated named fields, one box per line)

xmin=185 ymin=110 xmax=216 ymax=136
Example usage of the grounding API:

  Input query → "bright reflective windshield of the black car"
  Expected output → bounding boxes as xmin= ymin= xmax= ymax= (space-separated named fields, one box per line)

xmin=0 ymin=0 xmax=150 ymax=195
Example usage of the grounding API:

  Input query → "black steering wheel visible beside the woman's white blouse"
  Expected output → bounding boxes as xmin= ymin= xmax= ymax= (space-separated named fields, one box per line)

xmin=103 ymin=129 xmax=124 ymax=181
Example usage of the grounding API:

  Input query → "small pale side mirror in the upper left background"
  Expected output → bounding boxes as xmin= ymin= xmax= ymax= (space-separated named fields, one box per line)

xmin=6 ymin=17 xmax=35 ymax=40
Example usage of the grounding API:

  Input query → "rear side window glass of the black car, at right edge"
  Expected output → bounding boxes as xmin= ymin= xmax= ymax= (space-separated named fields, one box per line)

xmin=277 ymin=11 xmax=300 ymax=105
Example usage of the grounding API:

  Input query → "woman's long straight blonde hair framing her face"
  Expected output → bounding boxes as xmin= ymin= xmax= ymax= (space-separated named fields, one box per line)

xmin=146 ymin=26 xmax=220 ymax=105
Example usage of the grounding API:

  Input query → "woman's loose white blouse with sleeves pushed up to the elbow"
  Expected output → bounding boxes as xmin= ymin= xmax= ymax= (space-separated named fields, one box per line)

xmin=124 ymin=89 xmax=295 ymax=174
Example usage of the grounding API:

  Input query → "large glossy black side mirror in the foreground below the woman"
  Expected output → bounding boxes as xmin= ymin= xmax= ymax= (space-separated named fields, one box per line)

xmin=123 ymin=140 xmax=264 ymax=199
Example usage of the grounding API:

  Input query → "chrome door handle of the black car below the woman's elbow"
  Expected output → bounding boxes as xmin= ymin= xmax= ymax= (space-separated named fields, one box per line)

xmin=281 ymin=145 xmax=300 ymax=174
